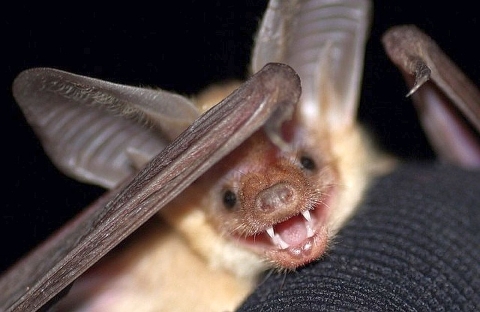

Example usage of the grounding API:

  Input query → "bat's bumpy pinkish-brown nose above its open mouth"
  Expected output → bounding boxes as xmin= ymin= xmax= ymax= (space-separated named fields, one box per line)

xmin=255 ymin=183 xmax=295 ymax=213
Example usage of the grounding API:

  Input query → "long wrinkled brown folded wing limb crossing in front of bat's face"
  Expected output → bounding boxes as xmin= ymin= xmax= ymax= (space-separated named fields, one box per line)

xmin=0 ymin=64 xmax=301 ymax=311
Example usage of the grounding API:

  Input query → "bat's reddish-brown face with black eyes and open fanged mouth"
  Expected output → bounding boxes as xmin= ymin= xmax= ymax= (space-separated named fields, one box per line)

xmin=197 ymin=118 xmax=337 ymax=269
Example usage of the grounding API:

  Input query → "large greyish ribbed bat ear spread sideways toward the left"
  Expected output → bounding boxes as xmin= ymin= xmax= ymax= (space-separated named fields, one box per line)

xmin=13 ymin=68 xmax=199 ymax=188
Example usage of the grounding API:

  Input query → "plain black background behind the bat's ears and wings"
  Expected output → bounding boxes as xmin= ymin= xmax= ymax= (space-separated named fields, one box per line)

xmin=0 ymin=0 xmax=480 ymax=276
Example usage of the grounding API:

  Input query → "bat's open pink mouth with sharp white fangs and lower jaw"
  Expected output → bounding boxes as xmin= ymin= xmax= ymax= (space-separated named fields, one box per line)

xmin=232 ymin=202 xmax=328 ymax=269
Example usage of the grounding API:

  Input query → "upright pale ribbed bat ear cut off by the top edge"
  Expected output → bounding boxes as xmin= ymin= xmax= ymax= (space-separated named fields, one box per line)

xmin=251 ymin=0 xmax=371 ymax=129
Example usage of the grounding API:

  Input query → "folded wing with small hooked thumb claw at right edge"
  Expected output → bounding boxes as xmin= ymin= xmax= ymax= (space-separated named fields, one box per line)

xmin=382 ymin=25 xmax=480 ymax=168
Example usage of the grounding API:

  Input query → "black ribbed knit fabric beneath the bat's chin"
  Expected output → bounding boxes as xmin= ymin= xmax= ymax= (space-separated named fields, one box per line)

xmin=239 ymin=164 xmax=480 ymax=311
